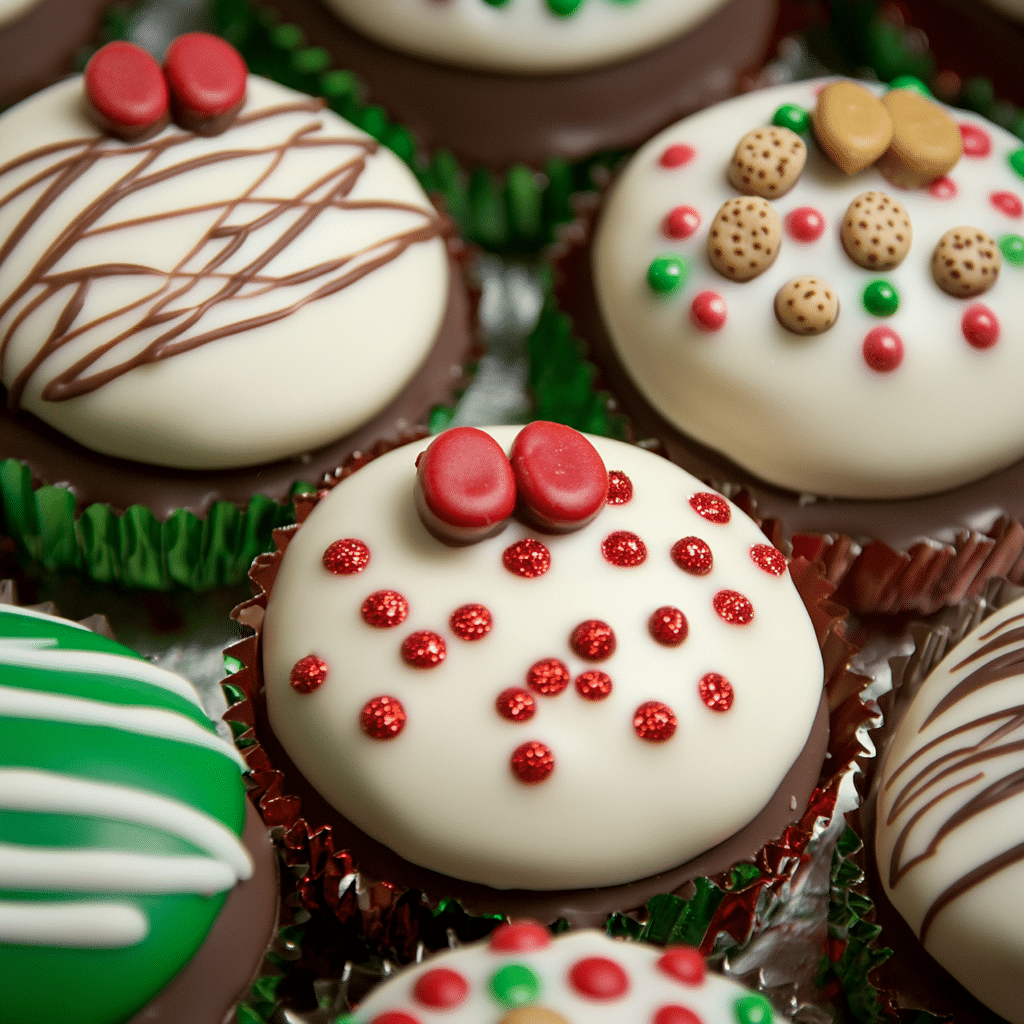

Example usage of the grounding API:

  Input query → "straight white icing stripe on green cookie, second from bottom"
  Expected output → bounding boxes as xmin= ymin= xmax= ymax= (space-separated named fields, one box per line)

xmin=0 ymin=843 xmax=238 ymax=896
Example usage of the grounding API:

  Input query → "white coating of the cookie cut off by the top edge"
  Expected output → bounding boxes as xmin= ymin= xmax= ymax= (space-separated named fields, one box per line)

xmin=324 ymin=0 xmax=725 ymax=74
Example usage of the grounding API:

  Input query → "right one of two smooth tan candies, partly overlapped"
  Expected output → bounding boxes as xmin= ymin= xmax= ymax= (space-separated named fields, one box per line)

xmin=878 ymin=89 xmax=964 ymax=188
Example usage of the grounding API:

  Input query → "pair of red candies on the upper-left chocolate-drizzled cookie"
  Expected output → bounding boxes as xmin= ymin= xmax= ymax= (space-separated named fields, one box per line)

xmin=85 ymin=32 xmax=249 ymax=142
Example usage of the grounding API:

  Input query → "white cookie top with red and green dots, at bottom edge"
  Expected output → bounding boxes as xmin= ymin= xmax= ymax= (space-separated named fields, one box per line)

xmin=339 ymin=922 xmax=775 ymax=1024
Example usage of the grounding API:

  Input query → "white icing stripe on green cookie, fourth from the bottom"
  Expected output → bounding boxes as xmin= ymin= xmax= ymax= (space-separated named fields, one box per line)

xmin=0 ymin=686 xmax=247 ymax=771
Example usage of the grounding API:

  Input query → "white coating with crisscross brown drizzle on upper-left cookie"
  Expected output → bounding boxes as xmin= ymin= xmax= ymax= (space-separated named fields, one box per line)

xmin=0 ymin=76 xmax=449 ymax=469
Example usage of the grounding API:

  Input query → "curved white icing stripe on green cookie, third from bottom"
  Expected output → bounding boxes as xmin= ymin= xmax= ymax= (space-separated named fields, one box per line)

xmin=0 ymin=768 xmax=253 ymax=879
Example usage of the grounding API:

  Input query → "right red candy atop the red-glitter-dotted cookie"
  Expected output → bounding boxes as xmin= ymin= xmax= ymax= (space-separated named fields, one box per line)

xmin=511 ymin=420 xmax=608 ymax=531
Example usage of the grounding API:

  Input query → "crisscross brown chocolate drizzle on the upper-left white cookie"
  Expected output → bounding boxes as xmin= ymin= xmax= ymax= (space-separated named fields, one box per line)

xmin=0 ymin=99 xmax=443 ymax=411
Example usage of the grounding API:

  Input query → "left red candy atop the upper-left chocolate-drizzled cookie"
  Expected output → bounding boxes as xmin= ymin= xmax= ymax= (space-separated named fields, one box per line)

xmin=85 ymin=42 xmax=170 ymax=141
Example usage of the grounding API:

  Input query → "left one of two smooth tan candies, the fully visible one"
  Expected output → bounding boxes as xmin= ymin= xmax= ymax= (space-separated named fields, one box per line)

xmin=812 ymin=82 xmax=893 ymax=174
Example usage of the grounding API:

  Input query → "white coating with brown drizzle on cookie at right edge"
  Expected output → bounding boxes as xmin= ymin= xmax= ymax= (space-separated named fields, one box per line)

xmin=874 ymin=600 xmax=1024 ymax=1024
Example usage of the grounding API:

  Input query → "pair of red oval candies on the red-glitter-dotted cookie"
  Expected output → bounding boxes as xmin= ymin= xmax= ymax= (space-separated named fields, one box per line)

xmin=416 ymin=421 xmax=608 ymax=544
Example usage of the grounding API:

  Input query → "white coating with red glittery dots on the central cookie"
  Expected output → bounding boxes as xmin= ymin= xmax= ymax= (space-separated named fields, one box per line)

xmin=263 ymin=427 xmax=822 ymax=890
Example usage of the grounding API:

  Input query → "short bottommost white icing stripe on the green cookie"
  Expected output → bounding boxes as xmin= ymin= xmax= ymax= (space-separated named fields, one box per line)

xmin=0 ymin=901 xmax=150 ymax=949
